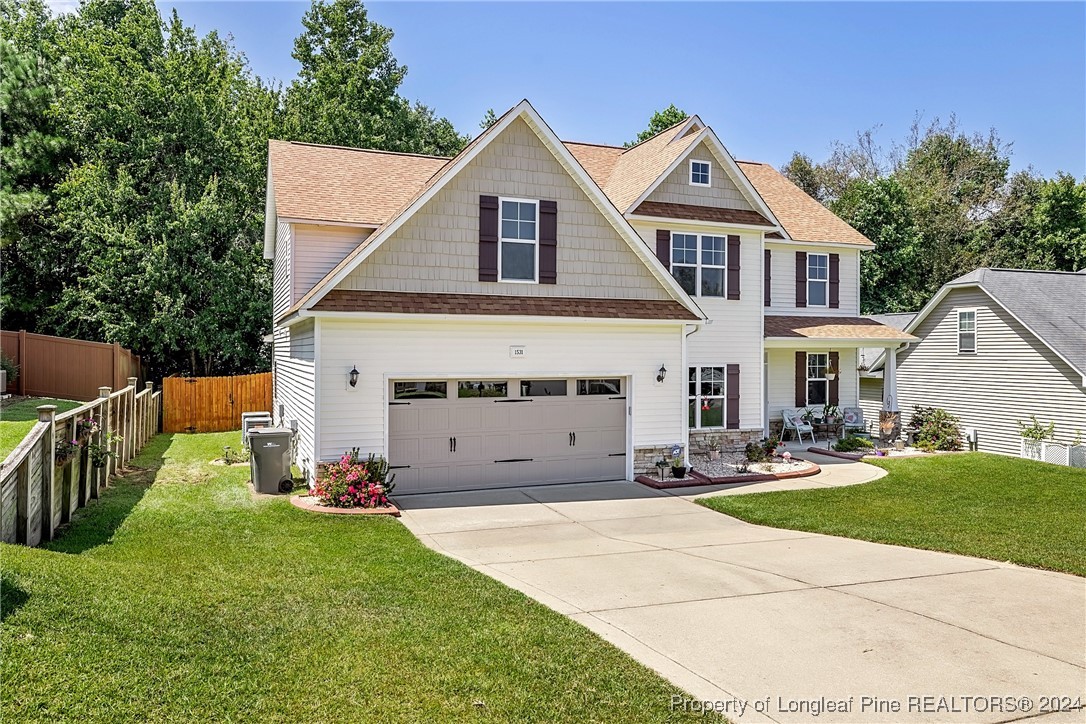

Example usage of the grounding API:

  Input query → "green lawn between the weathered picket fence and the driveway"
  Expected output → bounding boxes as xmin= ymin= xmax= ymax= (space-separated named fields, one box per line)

xmin=0 ymin=432 xmax=708 ymax=723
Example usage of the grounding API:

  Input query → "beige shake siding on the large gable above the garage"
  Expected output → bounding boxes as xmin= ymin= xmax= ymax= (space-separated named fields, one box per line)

xmin=338 ymin=119 xmax=670 ymax=300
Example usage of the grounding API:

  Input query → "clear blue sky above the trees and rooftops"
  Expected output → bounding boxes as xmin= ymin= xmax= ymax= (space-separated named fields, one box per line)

xmin=160 ymin=2 xmax=1086 ymax=178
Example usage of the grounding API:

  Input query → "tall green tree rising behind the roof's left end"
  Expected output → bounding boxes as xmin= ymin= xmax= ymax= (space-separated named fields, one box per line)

xmin=283 ymin=0 xmax=467 ymax=155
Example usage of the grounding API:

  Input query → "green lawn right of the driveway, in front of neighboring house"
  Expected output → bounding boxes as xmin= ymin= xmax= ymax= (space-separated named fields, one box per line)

xmin=698 ymin=453 xmax=1086 ymax=575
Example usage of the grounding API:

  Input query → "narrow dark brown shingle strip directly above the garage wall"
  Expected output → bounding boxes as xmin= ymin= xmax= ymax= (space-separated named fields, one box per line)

xmin=313 ymin=289 xmax=697 ymax=321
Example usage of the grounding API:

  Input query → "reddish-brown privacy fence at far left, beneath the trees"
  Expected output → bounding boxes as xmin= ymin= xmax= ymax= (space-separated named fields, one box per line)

xmin=0 ymin=330 xmax=141 ymax=399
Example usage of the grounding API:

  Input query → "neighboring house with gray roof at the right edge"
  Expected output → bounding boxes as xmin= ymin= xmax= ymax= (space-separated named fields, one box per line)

xmin=860 ymin=268 xmax=1086 ymax=455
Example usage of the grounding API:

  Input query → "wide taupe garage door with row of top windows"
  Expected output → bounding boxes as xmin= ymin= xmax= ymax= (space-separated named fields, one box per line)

xmin=389 ymin=378 xmax=627 ymax=493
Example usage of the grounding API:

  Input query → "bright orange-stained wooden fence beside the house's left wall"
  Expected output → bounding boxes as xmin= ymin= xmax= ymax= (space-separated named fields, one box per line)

xmin=162 ymin=372 xmax=272 ymax=432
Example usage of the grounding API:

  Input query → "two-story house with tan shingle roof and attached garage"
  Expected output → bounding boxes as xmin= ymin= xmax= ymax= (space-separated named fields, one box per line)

xmin=265 ymin=101 xmax=912 ymax=493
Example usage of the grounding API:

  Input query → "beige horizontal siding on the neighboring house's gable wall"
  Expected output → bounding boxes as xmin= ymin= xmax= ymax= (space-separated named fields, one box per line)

xmin=897 ymin=288 xmax=1086 ymax=455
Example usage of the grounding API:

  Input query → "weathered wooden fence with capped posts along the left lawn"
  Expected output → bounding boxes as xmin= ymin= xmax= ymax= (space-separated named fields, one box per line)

xmin=0 ymin=377 xmax=162 ymax=546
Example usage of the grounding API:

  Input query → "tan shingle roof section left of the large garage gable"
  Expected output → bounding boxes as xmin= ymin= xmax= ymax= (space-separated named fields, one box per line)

xmin=268 ymin=140 xmax=449 ymax=226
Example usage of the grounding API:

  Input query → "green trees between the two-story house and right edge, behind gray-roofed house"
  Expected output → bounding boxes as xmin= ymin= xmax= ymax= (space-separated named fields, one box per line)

xmin=782 ymin=117 xmax=1086 ymax=314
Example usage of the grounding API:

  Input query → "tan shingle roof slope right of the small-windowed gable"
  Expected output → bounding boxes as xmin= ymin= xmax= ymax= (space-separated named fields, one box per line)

xmin=736 ymin=161 xmax=872 ymax=246
